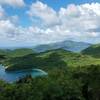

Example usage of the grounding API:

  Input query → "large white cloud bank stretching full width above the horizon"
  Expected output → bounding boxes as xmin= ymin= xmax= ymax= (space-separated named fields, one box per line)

xmin=0 ymin=1 xmax=100 ymax=45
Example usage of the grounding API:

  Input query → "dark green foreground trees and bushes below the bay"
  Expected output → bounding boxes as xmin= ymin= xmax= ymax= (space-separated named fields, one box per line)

xmin=0 ymin=65 xmax=100 ymax=100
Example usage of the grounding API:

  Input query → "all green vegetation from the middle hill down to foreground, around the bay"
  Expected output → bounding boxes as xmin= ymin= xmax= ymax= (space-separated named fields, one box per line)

xmin=0 ymin=49 xmax=100 ymax=100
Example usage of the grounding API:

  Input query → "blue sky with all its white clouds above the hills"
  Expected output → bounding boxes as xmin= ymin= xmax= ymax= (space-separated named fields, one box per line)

xmin=0 ymin=0 xmax=100 ymax=47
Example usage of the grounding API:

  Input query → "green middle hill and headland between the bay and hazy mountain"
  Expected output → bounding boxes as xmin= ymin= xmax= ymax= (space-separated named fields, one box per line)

xmin=3 ymin=49 xmax=100 ymax=70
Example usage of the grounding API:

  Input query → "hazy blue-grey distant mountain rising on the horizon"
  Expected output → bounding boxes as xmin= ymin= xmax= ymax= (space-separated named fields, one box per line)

xmin=33 ymin=40 xmax=91 ymax=52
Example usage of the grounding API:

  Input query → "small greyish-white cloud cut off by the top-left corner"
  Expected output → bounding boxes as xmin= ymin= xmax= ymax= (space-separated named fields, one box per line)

xmin=0 ymin=0 xmax=25 ymax=7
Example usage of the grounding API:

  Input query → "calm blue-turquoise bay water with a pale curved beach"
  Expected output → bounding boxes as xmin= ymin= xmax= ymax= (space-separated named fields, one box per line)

xmin=0 ymin=65 xmax=47 ymax=83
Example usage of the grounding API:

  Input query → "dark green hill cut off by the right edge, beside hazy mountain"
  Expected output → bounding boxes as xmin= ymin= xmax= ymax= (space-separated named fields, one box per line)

xmin=82 ymin=44 xmax=100 ymax=58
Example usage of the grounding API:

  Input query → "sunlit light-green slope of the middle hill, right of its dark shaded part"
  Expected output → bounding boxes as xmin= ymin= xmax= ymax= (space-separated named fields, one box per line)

xmin=38 ymin=49 xmax=100 ymax=66
